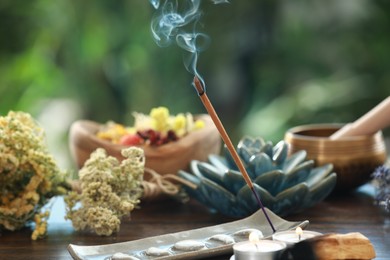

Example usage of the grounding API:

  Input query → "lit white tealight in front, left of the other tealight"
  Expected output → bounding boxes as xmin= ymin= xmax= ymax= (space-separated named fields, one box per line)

xmin=231 ymin=232 xmax=286 ymax=260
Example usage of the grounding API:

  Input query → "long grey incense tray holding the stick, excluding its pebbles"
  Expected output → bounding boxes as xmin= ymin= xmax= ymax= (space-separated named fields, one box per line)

xmin=68 ymin=209 xmax=309 ymax=260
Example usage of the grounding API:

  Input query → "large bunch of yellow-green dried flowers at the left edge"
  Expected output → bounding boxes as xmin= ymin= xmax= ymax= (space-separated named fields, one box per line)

xmin=0 ymin=111 xmax=70 ymax=240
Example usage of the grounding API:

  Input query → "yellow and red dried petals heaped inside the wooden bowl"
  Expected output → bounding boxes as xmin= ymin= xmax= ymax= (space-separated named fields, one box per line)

xmin=97 ymin=107 xmax=205 ymax=146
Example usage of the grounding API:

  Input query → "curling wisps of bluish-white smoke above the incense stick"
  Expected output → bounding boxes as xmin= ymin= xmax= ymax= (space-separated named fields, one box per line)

xmin=149 ymin=0 xmax=228 ymax=91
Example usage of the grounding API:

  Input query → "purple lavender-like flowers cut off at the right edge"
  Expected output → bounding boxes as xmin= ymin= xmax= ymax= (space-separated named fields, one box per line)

xmin=372 ymin=165 xmax=390 ymax=212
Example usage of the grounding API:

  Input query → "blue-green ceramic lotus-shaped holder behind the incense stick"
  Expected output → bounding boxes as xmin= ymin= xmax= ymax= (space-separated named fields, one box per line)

xmin=178 ymin=137 xmax=336 ymax=217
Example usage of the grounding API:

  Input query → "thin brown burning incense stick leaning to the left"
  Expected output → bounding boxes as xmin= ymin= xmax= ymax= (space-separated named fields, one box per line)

xmin=193 ymin=76 xmax=276 ymax=233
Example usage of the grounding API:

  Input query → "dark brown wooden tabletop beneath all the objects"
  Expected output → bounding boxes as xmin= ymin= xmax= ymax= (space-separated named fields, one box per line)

xmin=0 ymin=186 xmax=390 ymax=260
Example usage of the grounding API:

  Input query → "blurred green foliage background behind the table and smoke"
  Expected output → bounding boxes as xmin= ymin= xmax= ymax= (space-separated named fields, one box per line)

xmin=0 ymin=0 xmax=390 ymax=169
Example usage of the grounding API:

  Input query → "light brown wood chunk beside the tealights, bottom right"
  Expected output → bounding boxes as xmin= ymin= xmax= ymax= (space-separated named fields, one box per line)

xmin=312 ymin=232 xmax=375 ymax=260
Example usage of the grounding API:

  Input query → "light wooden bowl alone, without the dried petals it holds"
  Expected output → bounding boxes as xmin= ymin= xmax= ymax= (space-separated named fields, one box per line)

xmin=69 ymin=114 xmax=221 ymax=174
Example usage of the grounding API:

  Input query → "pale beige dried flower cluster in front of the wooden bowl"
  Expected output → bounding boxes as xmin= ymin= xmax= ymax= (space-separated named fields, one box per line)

xmin=65 ymin=147 xmax=145 ymax=236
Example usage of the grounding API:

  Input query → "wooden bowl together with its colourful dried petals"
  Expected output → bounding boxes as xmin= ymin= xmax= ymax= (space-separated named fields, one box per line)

xmin=69 ymin=107 xmax=221 ymax=178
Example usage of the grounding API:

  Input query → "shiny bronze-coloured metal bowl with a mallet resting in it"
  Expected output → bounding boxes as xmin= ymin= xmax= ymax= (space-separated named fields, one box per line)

xmin=285 ymin=124 xmax=387 ymax=192
